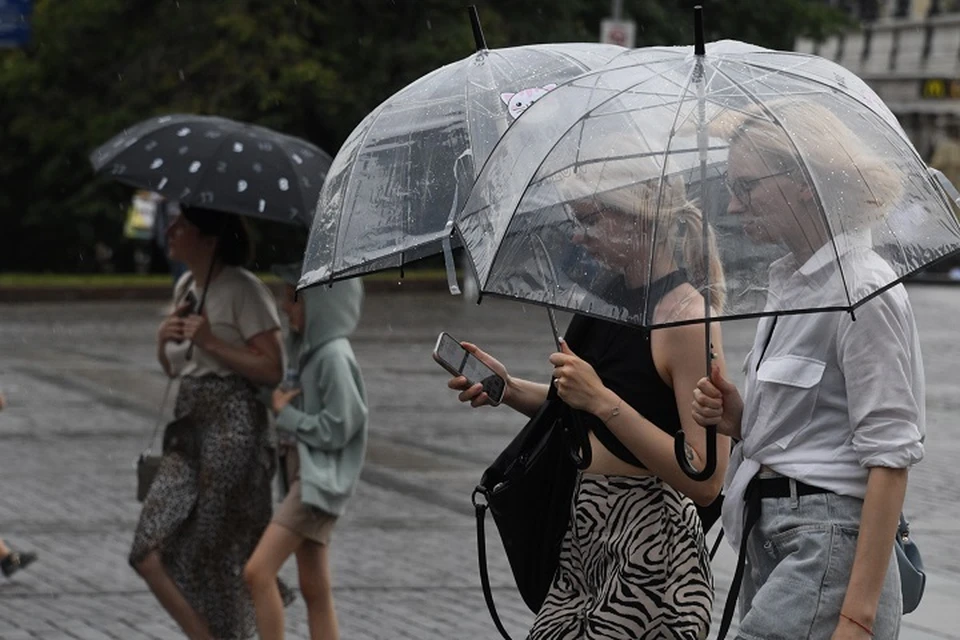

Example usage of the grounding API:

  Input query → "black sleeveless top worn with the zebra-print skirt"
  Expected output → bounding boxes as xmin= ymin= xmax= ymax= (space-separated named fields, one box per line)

xmin=566 ymin=270 xmax=687 ymax=468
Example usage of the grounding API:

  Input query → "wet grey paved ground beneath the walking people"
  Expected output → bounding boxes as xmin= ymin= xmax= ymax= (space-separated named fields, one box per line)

xmin=0 ymin=285 xmax=960 ymax=640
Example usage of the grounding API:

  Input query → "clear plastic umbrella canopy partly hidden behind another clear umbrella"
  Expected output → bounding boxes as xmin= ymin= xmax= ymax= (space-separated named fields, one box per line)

xmin=300 ymin=43 xmax=626 ymax=287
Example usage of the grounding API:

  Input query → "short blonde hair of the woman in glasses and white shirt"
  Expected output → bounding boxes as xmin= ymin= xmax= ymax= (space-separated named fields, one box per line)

xmin=710 ymin=98 xmax=903 ymax=231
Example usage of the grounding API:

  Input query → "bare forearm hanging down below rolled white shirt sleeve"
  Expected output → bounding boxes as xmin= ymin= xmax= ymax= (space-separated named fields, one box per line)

xmin=841 ymin=467 xmax=907 ymax=627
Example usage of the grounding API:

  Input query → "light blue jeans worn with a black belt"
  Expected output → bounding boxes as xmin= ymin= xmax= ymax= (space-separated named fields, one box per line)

xmin=737 ymin=493 xmax=903 ymax=640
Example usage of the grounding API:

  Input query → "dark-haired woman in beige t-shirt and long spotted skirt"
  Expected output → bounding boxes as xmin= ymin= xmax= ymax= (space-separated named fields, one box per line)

xmin=130 ymin=208 xmax=289 ymax=640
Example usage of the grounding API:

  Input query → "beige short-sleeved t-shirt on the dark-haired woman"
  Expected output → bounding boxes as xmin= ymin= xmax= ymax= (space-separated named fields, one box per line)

xmin=164 ymin=266 xmax=280 ymax=376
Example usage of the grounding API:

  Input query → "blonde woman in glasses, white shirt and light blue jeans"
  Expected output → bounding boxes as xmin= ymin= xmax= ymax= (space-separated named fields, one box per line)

xmin=693 ymin=99 xmax=924 ymax=640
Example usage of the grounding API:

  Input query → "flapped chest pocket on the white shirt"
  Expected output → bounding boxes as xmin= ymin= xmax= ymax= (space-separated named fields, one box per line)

xmin=757 ymin=355 xmax=827 ymax=449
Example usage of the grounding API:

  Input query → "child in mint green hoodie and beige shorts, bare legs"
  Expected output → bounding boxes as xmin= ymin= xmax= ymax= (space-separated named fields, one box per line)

xmin=244 ymin=267 xmax=367 ymax=640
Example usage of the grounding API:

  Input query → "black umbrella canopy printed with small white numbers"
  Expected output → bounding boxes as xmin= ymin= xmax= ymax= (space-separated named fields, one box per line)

xmin=90 ymin=114 xmax=331 ymax=227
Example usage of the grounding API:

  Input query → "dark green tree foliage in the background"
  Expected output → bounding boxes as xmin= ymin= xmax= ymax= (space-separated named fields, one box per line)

xmin=0 ymin=0 xmax=839 ymax=271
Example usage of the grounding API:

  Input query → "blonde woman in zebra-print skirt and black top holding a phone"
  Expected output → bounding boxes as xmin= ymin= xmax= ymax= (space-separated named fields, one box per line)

xmin=448 ymin=178 xmax=729 ymax=640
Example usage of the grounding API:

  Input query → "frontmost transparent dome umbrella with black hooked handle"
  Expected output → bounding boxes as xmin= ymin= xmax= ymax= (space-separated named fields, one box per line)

xmin=456 ymin=27 xmax=960 ymax=478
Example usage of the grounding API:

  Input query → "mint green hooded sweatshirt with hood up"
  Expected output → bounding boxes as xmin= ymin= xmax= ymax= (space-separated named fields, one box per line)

xmin=277 ymin=279 xmax=367 ymax=516
